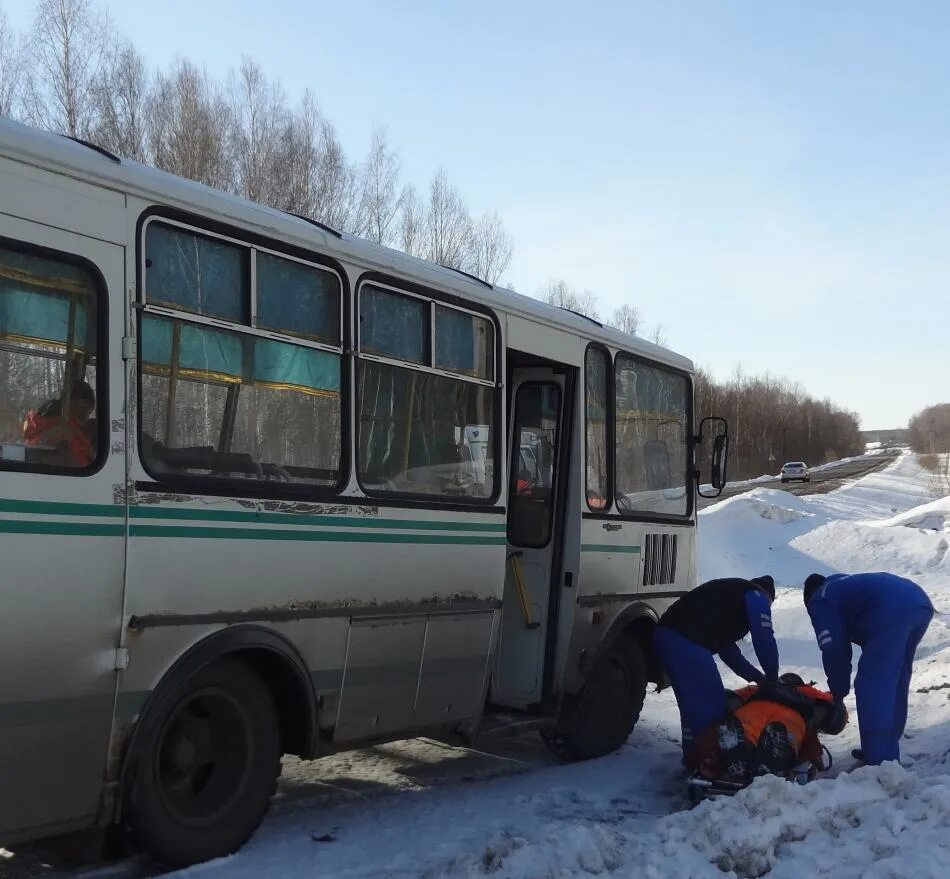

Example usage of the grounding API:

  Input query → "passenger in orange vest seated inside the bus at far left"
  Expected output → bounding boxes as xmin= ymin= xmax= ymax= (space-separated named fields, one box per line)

xmin=23 ymin=380 xmax=96 ymax=467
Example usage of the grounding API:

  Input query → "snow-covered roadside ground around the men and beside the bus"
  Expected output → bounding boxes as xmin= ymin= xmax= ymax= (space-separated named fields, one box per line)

xmin=175 ymin=455 xmax=950 ymax=879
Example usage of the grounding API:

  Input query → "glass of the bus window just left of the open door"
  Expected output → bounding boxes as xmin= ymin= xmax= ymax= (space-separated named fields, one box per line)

xmin=357 ymin=284 xmax=495 ymax=500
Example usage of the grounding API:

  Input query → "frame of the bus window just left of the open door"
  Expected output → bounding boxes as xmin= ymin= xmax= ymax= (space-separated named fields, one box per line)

xmin=352 ymin=271 xmax=507 ymax=512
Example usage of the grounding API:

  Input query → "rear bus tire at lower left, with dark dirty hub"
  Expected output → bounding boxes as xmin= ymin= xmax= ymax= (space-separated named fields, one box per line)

xmin=124 ymin=658 xmax=281 ymax=867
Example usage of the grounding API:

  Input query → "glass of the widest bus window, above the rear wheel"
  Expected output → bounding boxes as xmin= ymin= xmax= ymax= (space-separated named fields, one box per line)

xmin=139 ymin=223 xmax=342 ymax=487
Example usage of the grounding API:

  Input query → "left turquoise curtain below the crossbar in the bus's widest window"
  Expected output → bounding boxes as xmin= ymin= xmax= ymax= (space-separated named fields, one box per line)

xmin=141 ymin=315 xmax=244 ymax=381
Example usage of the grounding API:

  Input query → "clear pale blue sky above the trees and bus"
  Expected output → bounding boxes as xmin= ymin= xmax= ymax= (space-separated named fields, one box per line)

xmin=0 ymin=0 xmax=950 ymax=428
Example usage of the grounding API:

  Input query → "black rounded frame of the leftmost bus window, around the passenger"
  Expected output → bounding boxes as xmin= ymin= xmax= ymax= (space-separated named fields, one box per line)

xmin=0 ymin=236 xmax=111 ymax=477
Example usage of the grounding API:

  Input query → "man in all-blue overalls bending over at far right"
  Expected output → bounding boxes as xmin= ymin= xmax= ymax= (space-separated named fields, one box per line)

xmin=805 ymin=574 xmax=934 ymax=765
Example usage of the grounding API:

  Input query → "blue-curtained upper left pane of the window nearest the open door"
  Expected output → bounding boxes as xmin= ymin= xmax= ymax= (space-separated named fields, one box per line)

xmin=360 ymin=285 xmax=429 ymax=364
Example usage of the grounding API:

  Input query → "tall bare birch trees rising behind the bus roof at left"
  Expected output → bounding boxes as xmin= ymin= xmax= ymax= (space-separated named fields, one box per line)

xmin=0 ymin=0 xmax=512 ymax=284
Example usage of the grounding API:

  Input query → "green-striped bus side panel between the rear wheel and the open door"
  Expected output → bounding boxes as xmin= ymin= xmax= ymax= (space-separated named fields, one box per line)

xmin=123 ymin=493 xmax=504 ymax=741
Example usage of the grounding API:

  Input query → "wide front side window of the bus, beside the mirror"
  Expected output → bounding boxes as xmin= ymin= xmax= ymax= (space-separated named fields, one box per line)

xmin=615 ymin=354 xmax=690 ymax=516
